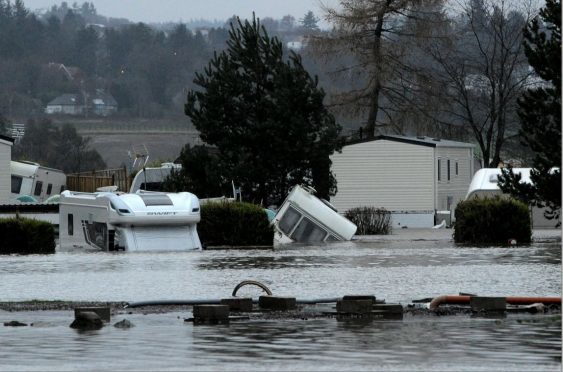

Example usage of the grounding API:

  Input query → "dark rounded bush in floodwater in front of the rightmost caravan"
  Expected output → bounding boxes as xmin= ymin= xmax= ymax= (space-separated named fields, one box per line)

xmin=454 ymin=197 xmax=532 ymax=245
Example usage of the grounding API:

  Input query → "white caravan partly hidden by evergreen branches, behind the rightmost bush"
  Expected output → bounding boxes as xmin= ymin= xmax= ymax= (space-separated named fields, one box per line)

xmin=465 ymin=168 xmax=558 ymax=228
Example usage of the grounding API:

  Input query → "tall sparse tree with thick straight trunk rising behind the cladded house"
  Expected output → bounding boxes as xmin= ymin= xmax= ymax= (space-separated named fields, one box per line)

xmin=313 ymin=0 xmax=443 ymax=137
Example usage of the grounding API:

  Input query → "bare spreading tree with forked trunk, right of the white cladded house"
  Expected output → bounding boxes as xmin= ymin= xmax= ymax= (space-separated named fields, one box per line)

xmin=427 ymin=0 xmax=534 ymax=167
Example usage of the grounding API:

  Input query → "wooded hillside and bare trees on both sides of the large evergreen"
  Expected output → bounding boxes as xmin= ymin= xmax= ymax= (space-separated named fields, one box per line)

xmin=0 ymin=0 xmax=552 ymax=166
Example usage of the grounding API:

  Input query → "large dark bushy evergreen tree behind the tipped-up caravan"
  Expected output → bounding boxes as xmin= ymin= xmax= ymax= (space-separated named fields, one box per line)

xmin=185 ymin=18 xmax=340 ymax=204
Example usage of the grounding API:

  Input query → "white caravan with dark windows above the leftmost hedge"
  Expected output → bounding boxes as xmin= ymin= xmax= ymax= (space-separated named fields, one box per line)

xmin=10 ymin=161 xmax=66 ymax=202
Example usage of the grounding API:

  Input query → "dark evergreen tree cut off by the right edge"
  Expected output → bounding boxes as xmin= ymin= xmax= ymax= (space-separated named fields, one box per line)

xmin=499 ymin=0 xmax=561 ymax=219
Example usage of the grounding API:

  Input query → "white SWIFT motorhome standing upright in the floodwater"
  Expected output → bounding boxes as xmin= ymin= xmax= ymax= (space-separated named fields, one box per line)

xmin=59 ymin=191 xmax=201 ymax=251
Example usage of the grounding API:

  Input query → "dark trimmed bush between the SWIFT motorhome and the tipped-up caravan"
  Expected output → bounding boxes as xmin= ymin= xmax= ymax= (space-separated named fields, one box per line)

xmin=197 ymin=202 xmax=274 ymax=246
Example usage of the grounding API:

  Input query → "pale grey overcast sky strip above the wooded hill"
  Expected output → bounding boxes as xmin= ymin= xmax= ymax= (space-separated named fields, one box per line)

xmin=24 ymin=0 xmax=337 ymax=23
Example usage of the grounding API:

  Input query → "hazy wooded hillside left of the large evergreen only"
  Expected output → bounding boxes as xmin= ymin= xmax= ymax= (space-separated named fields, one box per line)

xmin=0 ymin=0 xmax=227 ymax=118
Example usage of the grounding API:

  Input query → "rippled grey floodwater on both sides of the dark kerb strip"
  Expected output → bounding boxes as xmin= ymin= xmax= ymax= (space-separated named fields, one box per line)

xmin=0 ymin=229 xmax=561 ymax=371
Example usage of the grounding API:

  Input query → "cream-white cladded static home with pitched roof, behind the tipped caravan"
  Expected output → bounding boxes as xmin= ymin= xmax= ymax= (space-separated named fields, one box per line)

xmin=331 ymin=135 xmax=475 ymax=228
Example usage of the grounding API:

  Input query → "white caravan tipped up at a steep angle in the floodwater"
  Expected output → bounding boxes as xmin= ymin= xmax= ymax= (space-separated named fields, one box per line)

xmin=272 ymin=185 xmax=357 ymax=244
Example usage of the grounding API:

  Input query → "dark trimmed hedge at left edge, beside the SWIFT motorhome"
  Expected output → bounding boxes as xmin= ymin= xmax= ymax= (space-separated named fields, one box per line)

xmin=0 ymin=217 xmax=55 ymax=254
